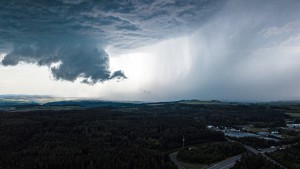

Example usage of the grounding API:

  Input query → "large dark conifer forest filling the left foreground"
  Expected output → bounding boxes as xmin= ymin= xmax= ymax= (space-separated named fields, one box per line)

xmin=0 ymin=108 xmax=224 ymax=169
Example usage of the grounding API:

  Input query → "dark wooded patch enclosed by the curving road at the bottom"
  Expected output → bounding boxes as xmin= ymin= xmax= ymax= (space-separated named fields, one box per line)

xmin=177 ymin=142 xmax=245 ymax=164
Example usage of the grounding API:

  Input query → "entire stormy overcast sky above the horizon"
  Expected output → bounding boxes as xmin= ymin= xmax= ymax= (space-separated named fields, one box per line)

xmin=0 ymin=0 xmax=300 ymax=101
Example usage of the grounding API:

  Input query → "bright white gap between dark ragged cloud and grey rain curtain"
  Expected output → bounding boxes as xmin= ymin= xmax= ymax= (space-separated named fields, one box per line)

xmin=108 ymin=36 xmax=193 ymax=101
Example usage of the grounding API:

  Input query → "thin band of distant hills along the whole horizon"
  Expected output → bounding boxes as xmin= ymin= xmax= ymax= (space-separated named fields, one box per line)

xmin=0 ymin=95 xmax=300 ymax=110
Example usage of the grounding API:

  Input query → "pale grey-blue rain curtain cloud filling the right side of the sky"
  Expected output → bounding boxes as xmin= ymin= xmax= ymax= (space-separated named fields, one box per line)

xmin=154 ymin=0 xmax=300 ymax=101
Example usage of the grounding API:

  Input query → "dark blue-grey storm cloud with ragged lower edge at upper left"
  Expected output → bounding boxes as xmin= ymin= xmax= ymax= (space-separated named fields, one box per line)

xmin=0 ymin=0 xmax=224 ymax=84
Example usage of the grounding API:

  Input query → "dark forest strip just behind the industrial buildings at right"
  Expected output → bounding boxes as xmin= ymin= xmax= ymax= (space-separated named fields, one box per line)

xmin=180 ymin=104 xmax=288 ymax=127
